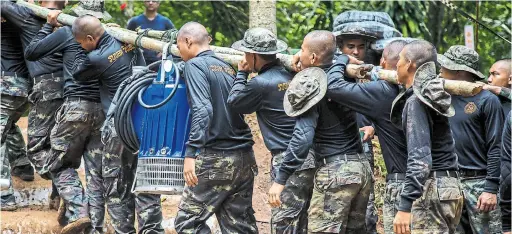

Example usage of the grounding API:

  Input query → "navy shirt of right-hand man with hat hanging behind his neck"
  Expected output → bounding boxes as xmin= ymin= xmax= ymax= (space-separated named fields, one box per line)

xmin=398 ymin=91 xmax=458 ymax=212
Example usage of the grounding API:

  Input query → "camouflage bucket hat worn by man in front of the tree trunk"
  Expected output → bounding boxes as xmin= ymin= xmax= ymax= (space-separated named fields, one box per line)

xmin=231 ymin=28 xmax=288 ymax=54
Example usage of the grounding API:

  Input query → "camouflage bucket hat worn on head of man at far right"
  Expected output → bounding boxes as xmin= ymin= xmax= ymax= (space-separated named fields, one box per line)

xmin=437 ymin=45 xmax=485 ymax=79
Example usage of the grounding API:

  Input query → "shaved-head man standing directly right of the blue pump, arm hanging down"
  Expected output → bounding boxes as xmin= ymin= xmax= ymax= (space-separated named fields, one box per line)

xmin=175 ymin=22 xmax=258 ymax=234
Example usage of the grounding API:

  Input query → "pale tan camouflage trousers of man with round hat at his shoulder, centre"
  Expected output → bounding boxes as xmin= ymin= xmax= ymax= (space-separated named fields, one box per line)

xmin=308 ymin=154 xmax=373 ymax=233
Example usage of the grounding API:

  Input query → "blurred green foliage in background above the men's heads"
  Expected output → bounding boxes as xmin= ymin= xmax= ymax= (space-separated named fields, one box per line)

xmin=106 ymin=0 xmax=511 ymax=74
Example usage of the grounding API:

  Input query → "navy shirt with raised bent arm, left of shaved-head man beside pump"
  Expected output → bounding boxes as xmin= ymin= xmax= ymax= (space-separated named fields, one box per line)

xmin=25 ymin=24 xmax=100 ymax=102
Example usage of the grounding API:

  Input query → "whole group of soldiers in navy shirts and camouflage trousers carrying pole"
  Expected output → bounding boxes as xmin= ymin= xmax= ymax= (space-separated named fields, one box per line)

xmin=0 ymin=0 xmax=512 ymax=234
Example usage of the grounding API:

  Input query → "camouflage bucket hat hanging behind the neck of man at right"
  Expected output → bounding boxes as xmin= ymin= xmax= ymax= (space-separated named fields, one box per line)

xmin=412 ymin=62 xmax=455 ymax=117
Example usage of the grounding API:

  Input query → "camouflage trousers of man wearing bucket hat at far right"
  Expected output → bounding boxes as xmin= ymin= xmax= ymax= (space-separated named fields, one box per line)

xmin=457 ymin=177 xmax=501 ymax=234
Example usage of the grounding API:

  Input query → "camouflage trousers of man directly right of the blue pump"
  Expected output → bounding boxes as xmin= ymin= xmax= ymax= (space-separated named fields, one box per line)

xmin=174 ymin=149 xmax=258 ymax=234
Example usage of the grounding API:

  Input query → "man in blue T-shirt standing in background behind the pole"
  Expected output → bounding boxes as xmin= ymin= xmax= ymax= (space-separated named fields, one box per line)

xmin=126 ymin=0 xmax=176 ymax=65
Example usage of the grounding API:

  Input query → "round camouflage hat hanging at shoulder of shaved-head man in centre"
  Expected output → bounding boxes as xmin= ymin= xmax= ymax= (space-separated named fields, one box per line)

xmin=283 ymin=67 xmax=327 ymax=117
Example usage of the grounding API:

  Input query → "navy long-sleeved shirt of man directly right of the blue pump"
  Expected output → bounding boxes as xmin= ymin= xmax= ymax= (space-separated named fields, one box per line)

xmin=184 ymin=50 xmax=254 ymax=158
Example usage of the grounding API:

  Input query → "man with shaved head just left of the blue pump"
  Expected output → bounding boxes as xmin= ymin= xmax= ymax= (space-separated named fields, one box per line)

xmin=72 ymin=15 xmax=164 ymax=233
